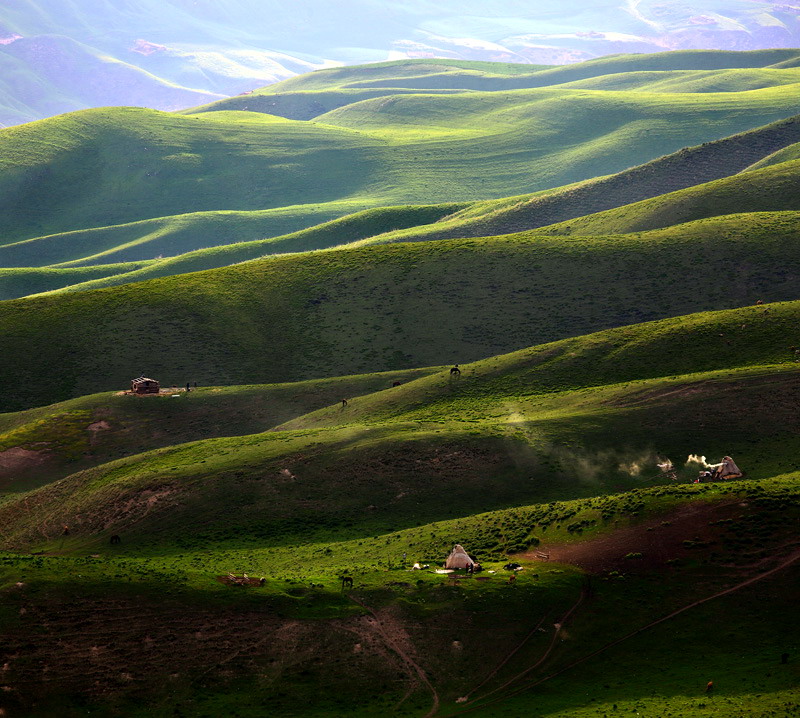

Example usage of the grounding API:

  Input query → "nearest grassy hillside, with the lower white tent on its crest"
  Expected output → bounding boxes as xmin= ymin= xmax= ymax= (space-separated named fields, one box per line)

xmin=0 ymin=475 xmax=798 ymax=718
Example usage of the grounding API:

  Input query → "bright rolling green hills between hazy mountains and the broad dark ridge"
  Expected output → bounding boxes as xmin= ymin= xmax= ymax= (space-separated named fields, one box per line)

xmin=0 ymin=50 xmax=800 ymax=298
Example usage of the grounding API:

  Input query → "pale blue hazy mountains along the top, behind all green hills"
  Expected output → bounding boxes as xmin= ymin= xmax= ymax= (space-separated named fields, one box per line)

xmin=0 ymin=0 xmax=800 ymax=125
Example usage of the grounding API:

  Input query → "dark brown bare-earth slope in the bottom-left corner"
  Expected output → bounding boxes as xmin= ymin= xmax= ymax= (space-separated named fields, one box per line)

xmin=0 ymin=584 xmax=418 ymax=715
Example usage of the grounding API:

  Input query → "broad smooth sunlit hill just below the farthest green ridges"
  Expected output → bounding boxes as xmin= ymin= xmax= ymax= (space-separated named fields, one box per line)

xmin=0 ymin=51 xmax=797 ymax=259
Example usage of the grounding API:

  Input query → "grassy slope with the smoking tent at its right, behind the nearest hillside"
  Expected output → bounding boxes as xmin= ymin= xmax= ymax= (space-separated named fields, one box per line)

xmin=3 ymin=292 xmax=800 ymax=545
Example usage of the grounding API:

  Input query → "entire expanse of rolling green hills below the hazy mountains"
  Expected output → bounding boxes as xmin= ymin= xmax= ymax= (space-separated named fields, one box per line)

xmin=0 ymin=49 xmax=800 ymax=718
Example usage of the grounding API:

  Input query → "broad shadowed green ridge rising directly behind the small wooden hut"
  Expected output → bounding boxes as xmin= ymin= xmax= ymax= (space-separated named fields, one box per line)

xmin=0 ymin=212 xmax=800 ymax=410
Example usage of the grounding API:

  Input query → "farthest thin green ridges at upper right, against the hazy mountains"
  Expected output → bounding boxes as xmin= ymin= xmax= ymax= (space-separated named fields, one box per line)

xmin=238 ymin=49 xmax=798 ymax=114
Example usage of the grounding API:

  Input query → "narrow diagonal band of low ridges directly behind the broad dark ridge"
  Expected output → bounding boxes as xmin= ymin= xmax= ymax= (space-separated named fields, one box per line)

xmin=0 ymin=113 xmax=800 ymax=298
